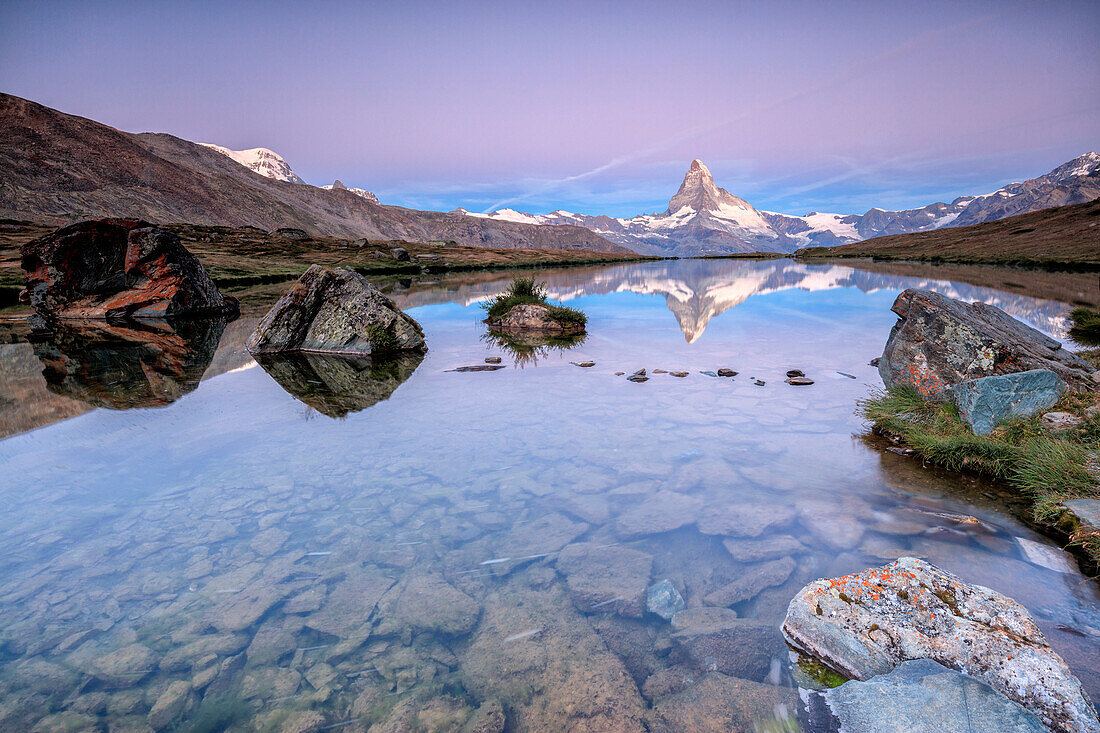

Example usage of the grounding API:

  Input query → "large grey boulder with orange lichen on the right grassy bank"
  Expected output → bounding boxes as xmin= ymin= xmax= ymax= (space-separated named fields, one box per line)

xmin=879 ymin=289 xmax=1097 ymax=400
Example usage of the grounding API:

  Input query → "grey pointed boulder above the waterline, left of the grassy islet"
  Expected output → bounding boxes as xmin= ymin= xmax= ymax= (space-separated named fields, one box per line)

xmin=244 ymin=265 xmax=428 ymax=357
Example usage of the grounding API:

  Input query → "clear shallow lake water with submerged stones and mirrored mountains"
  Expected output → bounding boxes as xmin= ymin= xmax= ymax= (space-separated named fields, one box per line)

xmin=0 ymin=261 xmax=1100 ymax=731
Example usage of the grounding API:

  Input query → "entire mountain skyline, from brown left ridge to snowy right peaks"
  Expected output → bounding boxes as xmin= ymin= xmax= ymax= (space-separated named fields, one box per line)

xmin=0 ymin=94 xmax=1100 ymax=256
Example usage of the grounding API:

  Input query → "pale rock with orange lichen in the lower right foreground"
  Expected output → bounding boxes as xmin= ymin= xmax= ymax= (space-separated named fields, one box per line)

xmin=783 ymin=557 xmax=1100 ymax=733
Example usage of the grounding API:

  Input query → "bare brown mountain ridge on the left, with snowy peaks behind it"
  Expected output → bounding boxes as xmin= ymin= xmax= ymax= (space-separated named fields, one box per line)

xmin=0 ymin=94 xmax=629 ymax=252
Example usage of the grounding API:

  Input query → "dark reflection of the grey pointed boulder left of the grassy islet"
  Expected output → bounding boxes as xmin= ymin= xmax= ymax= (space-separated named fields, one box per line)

xmin=256 ymin=352 xmax=424 ymax=417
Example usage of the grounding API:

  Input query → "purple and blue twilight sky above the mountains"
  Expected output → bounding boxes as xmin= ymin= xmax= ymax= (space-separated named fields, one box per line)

xmin=0 ymin=0 xmax=1100 ymax=216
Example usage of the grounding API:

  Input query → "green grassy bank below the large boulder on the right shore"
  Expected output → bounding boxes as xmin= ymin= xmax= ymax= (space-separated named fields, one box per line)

xmin=857 ymin=383 xmax=1100 ymax=562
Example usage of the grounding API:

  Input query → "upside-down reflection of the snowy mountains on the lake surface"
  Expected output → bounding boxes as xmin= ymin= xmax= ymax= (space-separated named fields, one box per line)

xmin=391 ymin=260 xmax=1068 ymax=343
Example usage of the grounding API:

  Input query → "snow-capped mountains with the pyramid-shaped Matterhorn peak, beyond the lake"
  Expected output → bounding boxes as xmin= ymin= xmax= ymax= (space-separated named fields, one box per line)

xmin=457 ymin=153 xmax=1100 ymax=255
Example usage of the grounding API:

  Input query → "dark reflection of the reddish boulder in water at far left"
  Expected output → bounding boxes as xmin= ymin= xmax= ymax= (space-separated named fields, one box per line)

xmin=33 ymin=318 xmax=226 ymax=409
